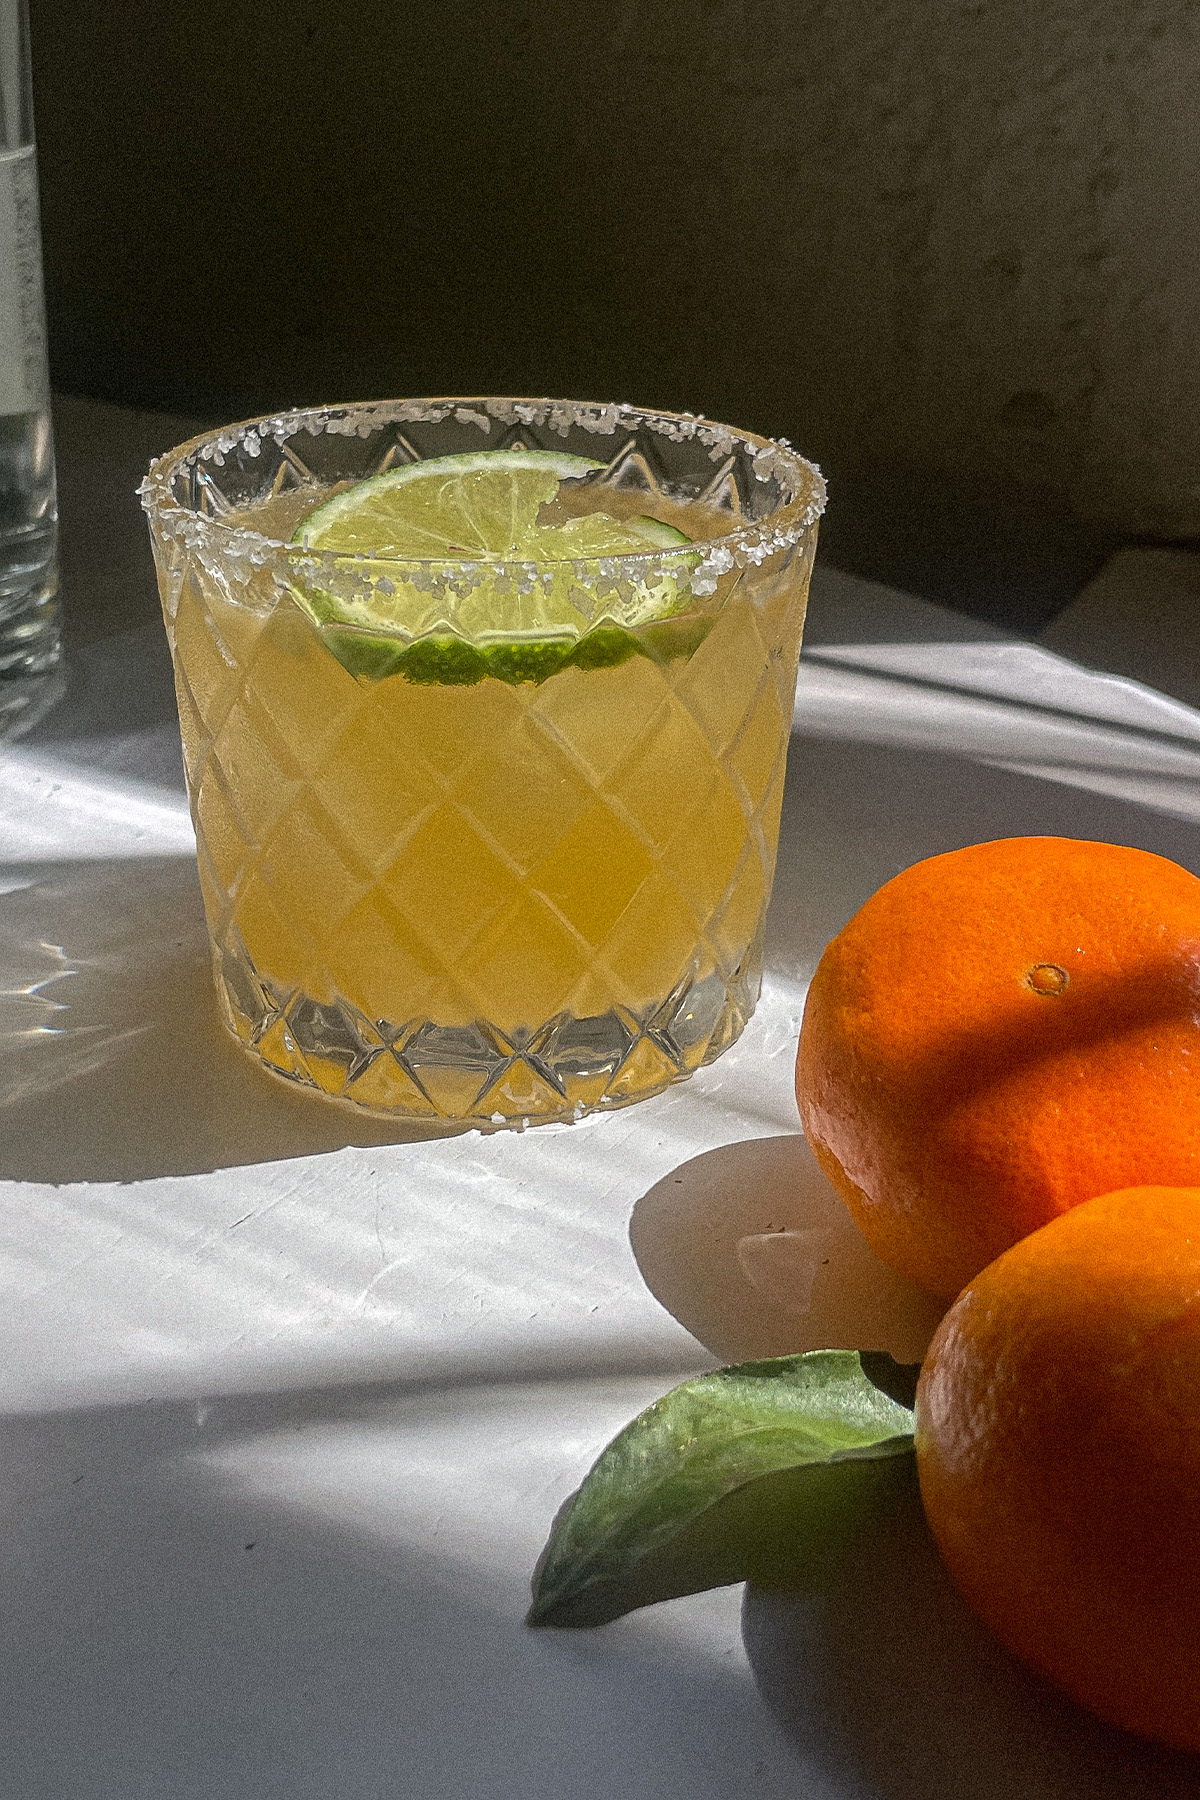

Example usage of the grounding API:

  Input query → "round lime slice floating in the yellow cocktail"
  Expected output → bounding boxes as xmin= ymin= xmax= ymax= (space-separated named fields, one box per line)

xmin=291 ymin=450 xmax=707 ymax=686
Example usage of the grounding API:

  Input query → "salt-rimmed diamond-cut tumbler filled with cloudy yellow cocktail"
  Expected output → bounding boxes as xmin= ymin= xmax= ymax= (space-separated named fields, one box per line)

xmin=142 ymin=400 xmax=824 ymax=1123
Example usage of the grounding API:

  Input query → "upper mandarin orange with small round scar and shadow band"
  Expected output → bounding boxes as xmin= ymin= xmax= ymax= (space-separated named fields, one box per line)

xmin=797 ymin=837 xmax=1200 ymax=1298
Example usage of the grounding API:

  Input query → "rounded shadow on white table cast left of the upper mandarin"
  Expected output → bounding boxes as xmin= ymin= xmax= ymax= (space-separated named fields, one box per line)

xmin=630 ymin=1134 xmax=945 ymax=1363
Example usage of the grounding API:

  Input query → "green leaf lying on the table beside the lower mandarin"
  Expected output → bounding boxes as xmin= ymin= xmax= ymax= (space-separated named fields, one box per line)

xmin=529 ymin=1350 xmax=912 ymax=1625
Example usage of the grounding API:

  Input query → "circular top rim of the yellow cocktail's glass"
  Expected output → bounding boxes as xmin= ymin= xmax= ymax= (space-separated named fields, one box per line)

xmin=137 ymin=396 xmax=826 ymax=580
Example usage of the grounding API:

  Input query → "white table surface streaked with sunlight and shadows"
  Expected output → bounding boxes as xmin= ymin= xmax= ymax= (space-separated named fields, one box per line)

xmin=0 ymin=417 xmax=1200 ymax=1800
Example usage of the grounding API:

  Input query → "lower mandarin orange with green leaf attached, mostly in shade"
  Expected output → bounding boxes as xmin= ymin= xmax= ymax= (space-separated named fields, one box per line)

xmin=916 ymin=1188 xmax=1200 ymax=1750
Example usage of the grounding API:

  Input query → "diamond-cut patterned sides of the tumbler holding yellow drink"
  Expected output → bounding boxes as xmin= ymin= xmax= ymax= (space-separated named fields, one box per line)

xmin=147 ymin=405 xmax=810 ymax=1125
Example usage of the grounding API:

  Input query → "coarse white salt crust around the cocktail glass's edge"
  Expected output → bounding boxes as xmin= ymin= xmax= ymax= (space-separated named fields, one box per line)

xmin=137 ymin=398 xmax=826 ymax=598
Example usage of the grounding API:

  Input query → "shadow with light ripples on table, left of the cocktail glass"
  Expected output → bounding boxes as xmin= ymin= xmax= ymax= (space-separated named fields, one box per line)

xmin=0 ymin=857 xmax=460 ymax=1183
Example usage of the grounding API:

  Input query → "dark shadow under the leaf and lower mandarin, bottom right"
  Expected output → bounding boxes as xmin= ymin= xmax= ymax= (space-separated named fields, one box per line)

xmin=743 ymin=1462 xmax=1200 ymax=1800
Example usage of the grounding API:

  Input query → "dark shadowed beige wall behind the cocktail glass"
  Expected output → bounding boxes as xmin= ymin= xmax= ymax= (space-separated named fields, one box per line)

xmin=32 ymin=0 xmax=1200 ymax=536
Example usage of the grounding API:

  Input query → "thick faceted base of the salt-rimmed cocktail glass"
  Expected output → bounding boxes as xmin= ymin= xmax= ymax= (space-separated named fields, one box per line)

xmin=216 ymin=940 xmax=763 ymax=1125
